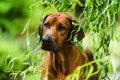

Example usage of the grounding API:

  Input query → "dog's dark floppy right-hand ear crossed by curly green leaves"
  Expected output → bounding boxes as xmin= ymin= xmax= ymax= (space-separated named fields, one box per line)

xmin=68 ymin=19 xmax=85 ymax=41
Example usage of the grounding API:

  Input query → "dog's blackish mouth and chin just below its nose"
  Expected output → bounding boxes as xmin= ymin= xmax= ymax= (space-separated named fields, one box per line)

xmin=41 ymin=41 xmax=61 ymax=52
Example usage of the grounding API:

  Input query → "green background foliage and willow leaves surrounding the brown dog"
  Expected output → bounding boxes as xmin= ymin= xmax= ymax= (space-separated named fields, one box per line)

xmin=0 ymin=0 xmax=120 ymax=80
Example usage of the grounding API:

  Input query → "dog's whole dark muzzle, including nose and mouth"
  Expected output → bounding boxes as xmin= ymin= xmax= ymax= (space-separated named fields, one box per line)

xmin=41 ymin=35 xmax=60 ymax=51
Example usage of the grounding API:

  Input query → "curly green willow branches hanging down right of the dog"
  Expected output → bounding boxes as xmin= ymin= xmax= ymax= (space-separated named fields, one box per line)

xmin=79 ymin=0 xmax=119 ymax=79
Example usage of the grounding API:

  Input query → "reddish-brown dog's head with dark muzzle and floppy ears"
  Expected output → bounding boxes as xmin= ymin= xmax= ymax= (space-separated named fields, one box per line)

xmin=39 ymin=12 xmax=84 ymax=51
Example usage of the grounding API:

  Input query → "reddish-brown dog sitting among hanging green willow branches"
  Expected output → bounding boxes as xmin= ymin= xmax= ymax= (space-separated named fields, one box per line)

xmin=39 ymin=12 xmax=98 ymax=80
